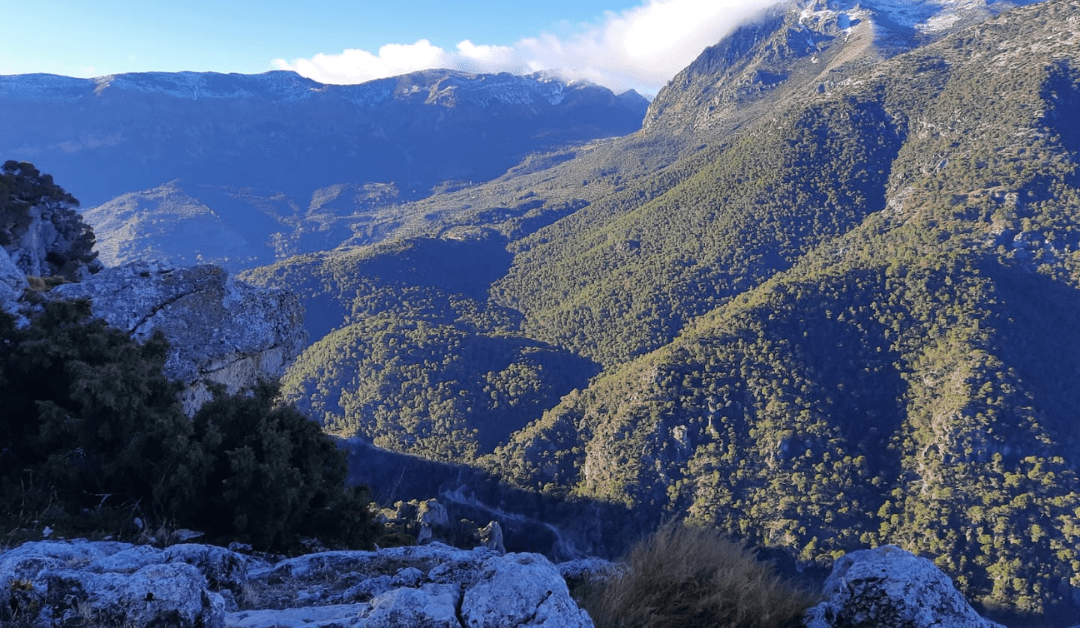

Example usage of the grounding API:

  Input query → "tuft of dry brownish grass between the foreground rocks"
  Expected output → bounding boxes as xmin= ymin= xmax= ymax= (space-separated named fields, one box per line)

xmin=582 ymin=524 xmax=812 ymax=628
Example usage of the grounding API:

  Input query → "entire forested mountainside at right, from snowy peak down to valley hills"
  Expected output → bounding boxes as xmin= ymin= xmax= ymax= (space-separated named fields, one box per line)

xmin=4 ymin=0 xmax=1080 ymax=625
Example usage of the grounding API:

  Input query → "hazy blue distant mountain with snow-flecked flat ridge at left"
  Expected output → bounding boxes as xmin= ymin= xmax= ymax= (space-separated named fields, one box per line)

xmin=0 ymin=70 xmax=648 ymax=268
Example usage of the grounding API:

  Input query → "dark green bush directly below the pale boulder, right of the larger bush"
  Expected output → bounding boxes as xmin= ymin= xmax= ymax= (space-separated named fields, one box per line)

xmin=191 ymin=376 xmax=375 ymax=548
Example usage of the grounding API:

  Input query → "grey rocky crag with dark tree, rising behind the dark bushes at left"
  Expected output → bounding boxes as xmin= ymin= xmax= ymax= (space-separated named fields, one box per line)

xmin=0 ymin=161 xmax=306 ymax=413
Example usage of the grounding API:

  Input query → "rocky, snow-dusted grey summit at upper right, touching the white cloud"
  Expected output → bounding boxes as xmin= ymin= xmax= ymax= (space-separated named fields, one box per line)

xmin=645 ymin=0 xmax=1034 ymax=133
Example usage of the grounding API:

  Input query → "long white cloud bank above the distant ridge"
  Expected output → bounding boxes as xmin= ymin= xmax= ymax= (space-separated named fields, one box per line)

xmin=273 ymin=0 xmax=777 ymax=94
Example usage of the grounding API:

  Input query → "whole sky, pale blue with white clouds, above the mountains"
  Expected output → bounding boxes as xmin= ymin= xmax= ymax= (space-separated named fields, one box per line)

xmin=0 ymin=0 xmax=775 ymax=96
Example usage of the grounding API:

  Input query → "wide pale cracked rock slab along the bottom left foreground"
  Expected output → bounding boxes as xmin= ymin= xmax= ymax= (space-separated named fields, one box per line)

xmin=0 ymin=542 xmax=593 ymax=628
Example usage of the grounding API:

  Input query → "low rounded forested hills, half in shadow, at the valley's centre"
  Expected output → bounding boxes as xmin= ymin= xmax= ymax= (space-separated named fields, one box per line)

xmin=239 ymin=230 xmax=597 ymax=462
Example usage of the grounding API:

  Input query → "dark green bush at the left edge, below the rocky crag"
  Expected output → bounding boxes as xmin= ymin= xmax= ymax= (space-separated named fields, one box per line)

xmin=0 ymin=302 xmax=205 ymax=518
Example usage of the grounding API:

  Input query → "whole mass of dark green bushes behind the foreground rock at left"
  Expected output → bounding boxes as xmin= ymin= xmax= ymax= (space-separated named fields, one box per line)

xmin=0 ymin=302 xmax=374 ymax=549
